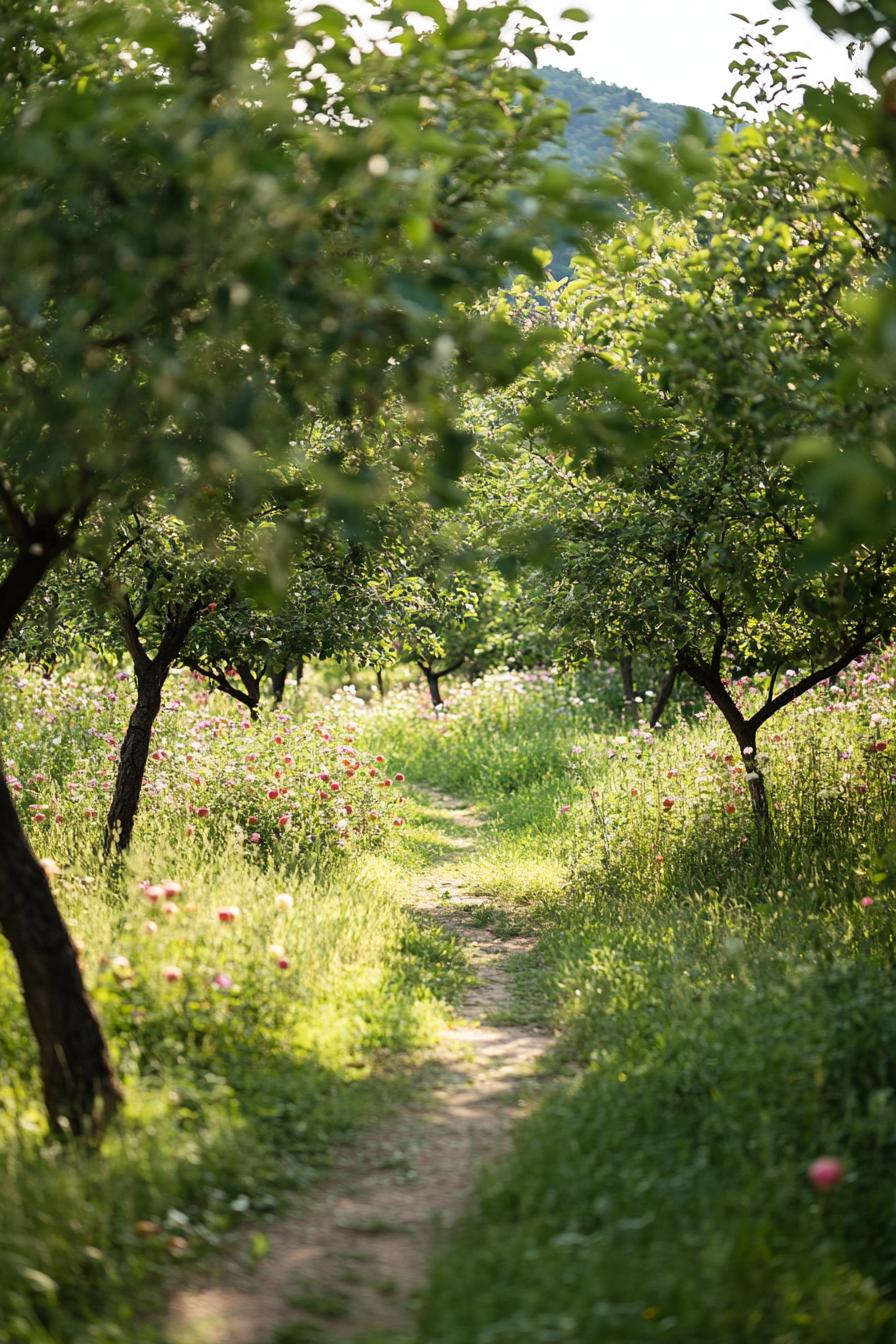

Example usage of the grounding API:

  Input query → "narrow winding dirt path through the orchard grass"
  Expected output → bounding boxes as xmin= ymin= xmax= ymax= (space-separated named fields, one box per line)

xmin=168 ymin=793 xmax=549 ymax=1344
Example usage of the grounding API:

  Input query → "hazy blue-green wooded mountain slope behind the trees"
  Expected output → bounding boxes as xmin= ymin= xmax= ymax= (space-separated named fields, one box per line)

xmin=539 ymin=66 xmax=721 ymax=172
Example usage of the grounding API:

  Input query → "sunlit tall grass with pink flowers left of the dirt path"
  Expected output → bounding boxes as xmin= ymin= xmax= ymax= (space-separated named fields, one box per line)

xmin=0 ymin=667 xmax=466 ymax=1344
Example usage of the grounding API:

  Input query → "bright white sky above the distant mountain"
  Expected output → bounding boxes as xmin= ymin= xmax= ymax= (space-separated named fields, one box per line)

xmin=533 ymin=0 xmax=850 ymax=112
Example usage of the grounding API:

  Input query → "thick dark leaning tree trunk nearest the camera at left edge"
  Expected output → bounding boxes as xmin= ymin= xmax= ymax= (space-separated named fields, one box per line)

xmin=0 ymin=775 xmax=121 ymax=1138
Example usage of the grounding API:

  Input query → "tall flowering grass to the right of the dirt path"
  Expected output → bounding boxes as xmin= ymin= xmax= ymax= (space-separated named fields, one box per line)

xmin=397 ymin=659 xmax=896 ymax=1344
